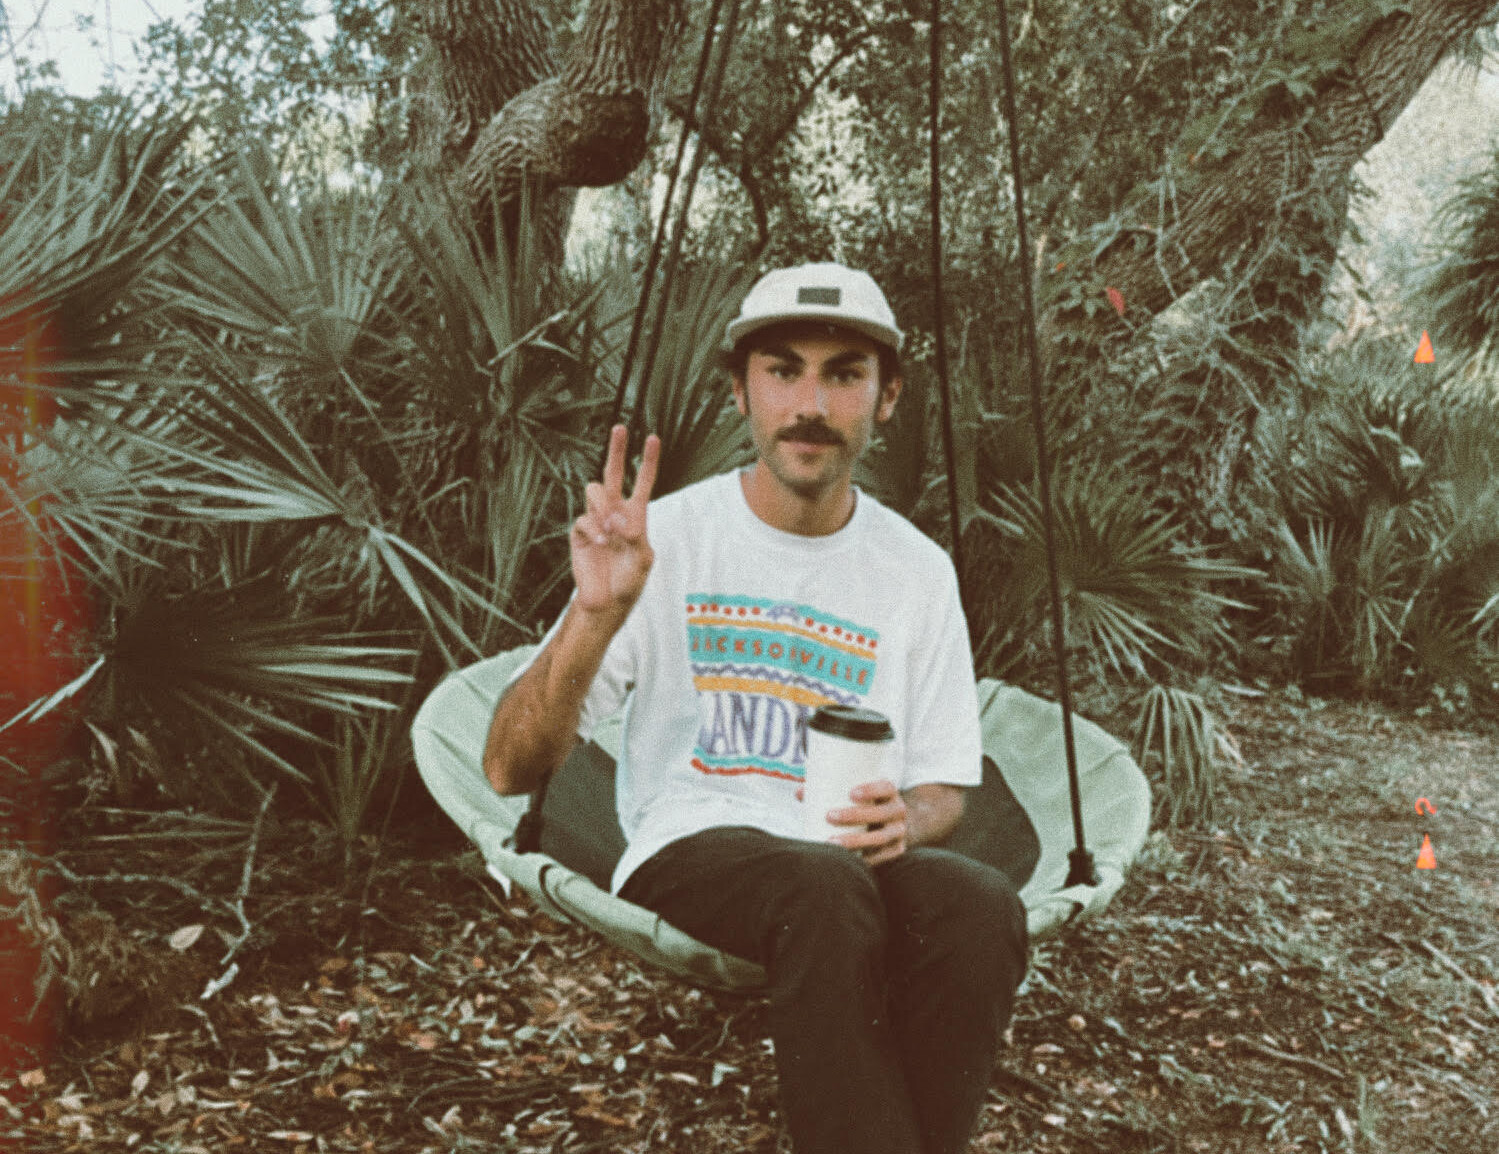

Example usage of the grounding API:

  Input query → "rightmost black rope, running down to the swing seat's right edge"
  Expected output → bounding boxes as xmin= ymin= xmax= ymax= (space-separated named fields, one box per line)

xmin=995 ymin=0 xmax=1099 ymax=886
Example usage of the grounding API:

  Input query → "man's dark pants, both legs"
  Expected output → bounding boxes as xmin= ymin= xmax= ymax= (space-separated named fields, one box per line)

xmin=621 ymin=827 xmax=1027 ymax=1154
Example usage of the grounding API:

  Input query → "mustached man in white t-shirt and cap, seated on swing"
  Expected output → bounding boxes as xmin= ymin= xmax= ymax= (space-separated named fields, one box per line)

xmin=484 ymin=264 xmax=1027 ymax=1154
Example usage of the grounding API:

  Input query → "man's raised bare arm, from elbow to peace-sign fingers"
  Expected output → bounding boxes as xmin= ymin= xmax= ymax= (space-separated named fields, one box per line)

xmin=484 ymin=424 xmax=661 ymax=794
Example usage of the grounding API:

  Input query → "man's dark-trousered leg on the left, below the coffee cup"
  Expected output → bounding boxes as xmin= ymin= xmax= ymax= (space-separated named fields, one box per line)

xmin=621 ymin=827 xmax=923 ymax=1154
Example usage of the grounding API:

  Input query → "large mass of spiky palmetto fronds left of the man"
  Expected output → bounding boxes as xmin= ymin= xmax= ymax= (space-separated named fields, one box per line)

xmin=0 ymin=116 xmax=755 ymax=845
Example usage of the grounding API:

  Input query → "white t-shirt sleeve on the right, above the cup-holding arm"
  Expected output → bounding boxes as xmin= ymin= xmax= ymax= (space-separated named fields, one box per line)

xmin=901 ymin=564 xmax=983 ymax=788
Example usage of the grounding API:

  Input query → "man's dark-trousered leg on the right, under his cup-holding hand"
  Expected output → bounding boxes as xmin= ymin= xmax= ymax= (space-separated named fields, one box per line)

xmin=874 ymin=848 xmax=1028 ymax=1154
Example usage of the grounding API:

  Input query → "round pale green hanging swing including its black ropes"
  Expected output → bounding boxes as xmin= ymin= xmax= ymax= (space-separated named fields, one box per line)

xmin=412 ymin=0 xmax=1151 ymax=989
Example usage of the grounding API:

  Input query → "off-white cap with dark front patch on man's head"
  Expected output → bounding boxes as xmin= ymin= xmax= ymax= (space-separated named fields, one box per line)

xmin=724 ymin=262 xmax=905 ymax=352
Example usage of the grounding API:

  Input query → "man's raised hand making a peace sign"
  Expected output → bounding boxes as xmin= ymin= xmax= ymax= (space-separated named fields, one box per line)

xmin=568 ymin=424 xmax=661 ymax=620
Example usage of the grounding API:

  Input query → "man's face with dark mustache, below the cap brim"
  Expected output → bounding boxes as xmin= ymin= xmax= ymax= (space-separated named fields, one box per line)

xmin=735 ymin=325 xmax=901 ymax=501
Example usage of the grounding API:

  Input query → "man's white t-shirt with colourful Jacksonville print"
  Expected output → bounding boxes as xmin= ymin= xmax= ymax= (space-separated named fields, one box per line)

xmin=516 ymin=472 xmax=982 ymax=893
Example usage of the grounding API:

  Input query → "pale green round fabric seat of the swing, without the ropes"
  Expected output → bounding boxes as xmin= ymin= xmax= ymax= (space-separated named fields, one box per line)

xmin=411 ymin=646 xmax=1150 ymax=989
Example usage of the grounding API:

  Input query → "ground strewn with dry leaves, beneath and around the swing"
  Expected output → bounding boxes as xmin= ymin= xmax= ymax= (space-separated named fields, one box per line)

xmin=0 ymin=689 xmax=1499 ymax=1154
